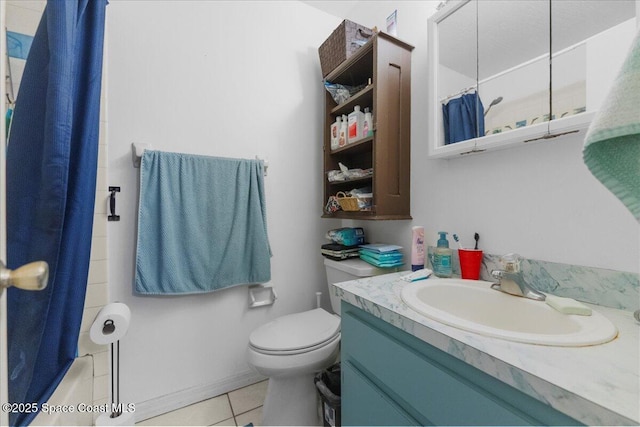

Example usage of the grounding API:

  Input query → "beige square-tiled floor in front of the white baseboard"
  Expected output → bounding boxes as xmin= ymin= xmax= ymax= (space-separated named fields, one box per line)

xmin=136 ymin=380 xmax=268 ymax=426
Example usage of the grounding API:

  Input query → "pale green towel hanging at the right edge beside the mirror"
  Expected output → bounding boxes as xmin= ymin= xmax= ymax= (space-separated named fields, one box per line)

xmin=583 ymin=27 xmax=640 ymax=221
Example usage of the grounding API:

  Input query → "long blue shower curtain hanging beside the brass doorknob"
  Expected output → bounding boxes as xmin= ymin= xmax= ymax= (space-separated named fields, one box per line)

xmin=7 ymin=0 xmax=106 ymax=425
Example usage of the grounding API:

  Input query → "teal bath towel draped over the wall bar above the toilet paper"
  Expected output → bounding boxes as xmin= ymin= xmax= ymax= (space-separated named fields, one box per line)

xmin=135 ymin=150 xmax=271 ymax=295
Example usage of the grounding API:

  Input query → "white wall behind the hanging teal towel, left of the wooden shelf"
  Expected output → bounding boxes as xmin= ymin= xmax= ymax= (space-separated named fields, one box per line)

xmin=107 ymin=1 xmax=340 ymax=412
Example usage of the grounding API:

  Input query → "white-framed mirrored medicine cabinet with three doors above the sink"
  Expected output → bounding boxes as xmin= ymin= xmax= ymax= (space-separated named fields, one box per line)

xmin=428 ymin=0 xmax=640 ymax=158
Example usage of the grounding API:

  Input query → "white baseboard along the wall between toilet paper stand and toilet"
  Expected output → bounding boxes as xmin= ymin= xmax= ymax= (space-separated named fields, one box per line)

xmin=134 ymin=370 xmax=266 ymax=422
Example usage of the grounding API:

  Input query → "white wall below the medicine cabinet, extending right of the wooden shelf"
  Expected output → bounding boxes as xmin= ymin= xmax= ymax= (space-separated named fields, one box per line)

xmin=346 ymin=1 xmax=640 ymax=273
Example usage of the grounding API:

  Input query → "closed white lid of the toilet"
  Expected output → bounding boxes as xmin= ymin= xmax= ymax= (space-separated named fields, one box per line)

xmin=249 ymin=308 xmax=340 ymax=351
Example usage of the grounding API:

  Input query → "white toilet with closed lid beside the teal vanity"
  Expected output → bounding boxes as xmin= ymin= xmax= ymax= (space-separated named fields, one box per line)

xmin=247 ymin=258 xmax=391 ymax=426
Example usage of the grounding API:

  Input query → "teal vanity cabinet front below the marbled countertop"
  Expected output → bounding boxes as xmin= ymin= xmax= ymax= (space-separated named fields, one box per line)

xmin=342 ymin=301 xmax=580 ymax=426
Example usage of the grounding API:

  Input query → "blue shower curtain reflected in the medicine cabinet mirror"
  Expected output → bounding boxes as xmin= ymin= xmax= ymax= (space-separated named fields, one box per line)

xmin=442 ymin=93 xmax=484 ymax=145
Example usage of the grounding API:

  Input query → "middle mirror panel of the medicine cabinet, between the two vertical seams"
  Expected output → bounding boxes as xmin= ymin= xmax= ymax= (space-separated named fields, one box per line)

xmin=474 ymin=0 xmax=550 ymax=135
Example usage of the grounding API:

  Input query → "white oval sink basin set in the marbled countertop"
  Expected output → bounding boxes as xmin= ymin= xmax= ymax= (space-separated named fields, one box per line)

xmin=401 ymin=278 xmax=618 ymax=347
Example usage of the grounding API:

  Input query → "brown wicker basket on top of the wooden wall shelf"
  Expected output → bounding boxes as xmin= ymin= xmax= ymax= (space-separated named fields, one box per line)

xmin=318 ymin=19 xmax=373 ymax=77
